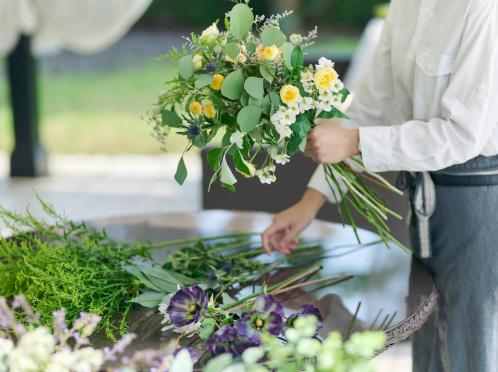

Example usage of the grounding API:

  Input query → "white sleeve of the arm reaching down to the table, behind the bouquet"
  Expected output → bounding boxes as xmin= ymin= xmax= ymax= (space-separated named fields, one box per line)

xmin=308 ymin=5 xmax=394 ymax=203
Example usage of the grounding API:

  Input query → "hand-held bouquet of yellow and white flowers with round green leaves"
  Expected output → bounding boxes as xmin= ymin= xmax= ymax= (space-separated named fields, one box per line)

xmin=150 ymin=2 xmax=401 ymax=247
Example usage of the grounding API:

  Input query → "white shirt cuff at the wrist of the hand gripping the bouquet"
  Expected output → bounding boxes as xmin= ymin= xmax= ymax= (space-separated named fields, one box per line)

xmin=359 ymin=126 xmax=396 ymax=172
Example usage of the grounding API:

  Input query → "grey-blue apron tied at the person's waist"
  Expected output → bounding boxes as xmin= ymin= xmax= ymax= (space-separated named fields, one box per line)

xmin=400 ymin=156 xmax=498 ymax=372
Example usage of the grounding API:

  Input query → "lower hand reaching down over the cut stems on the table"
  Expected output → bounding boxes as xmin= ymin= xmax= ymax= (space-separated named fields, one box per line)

xmin=261 ymin=189 xmax=326 ymax=255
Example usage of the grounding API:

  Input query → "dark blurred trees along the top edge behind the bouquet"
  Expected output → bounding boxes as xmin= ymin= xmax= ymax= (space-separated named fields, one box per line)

xmin=141 ymin=0 xmax=388 ymax=31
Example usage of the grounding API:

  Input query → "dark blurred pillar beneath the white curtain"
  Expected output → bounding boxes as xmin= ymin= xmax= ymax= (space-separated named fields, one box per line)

xmin=8 ymin=35 xmax=47 ymax=177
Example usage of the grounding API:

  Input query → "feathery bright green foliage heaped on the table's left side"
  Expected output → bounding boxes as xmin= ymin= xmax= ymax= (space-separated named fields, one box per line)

xmin=0 ymin=201 xmax=152 ymax=338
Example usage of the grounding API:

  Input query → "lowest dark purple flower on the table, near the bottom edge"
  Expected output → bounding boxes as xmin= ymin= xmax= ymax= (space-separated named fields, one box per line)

xmin=206 ymin=326 xmax=259 ymax=356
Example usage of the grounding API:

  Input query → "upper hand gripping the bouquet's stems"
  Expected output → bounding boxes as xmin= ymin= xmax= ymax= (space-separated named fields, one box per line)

xmin=304 ymin=119 xmax=360 ymax=164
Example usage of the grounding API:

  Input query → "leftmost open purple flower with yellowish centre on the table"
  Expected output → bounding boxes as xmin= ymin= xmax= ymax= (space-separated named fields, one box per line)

xmin=166 ymin=286 xmax=209 ymax=327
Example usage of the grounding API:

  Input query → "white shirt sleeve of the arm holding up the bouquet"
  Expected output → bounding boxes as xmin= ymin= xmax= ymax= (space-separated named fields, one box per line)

xmin=360 ymin=0 xmax=498 ymax=171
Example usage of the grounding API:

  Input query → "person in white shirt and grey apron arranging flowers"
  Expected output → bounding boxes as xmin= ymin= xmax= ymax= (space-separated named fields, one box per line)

xmin=262 ymin=0 xmax=498 ymax=372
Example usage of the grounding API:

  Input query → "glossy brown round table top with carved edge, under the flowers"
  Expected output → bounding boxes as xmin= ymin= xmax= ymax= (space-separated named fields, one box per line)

xmin=89 ymin=210 xmax=437 ymax=349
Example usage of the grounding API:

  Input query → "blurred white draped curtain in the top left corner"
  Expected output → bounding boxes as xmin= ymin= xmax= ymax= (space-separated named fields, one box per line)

xmin=0 ymin=0 xmax=152 ymax=55
